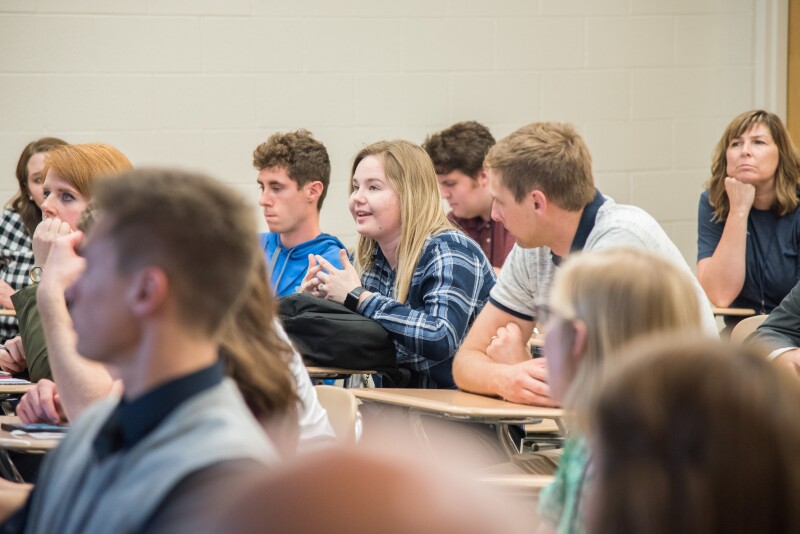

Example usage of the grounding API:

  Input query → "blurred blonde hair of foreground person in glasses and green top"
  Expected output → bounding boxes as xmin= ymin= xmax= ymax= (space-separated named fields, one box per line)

xmin=551 ymin=248 xmax=701 ymax=414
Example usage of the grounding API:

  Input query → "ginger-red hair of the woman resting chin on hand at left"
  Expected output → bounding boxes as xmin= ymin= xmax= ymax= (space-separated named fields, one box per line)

xmin=44 ymin=143 xmax=133 ymax=200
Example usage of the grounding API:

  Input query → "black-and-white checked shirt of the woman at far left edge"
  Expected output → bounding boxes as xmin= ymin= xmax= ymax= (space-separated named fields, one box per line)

xmin=0 ymin=210 xmax=33 ymax=340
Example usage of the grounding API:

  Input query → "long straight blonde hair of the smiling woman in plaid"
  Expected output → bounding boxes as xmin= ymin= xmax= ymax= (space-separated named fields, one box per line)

xmin=350 ymin=140 xmax=455 ymax=302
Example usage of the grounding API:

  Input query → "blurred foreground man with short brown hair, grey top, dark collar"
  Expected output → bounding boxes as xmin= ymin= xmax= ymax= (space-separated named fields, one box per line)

xmin=0 ymin=169 xmax=276 ymax=533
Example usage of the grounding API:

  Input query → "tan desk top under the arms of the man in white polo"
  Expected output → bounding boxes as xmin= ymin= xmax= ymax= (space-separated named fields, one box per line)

xmin=350 ymin=388 xmax=564 ymax=423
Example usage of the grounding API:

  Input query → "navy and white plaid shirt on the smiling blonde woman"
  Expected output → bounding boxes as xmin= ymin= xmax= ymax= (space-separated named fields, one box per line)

xmin=358 ymin=230 xmax=495 ymax=388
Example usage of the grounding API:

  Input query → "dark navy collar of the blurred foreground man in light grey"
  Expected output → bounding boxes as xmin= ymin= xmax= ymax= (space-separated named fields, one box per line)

xmin=93 ymin=360 xmax=225 ymax=460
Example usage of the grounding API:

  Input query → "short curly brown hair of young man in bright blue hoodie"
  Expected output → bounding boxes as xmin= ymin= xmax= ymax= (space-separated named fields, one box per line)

xmin=253 ymin=129 xmax=331 ymax=210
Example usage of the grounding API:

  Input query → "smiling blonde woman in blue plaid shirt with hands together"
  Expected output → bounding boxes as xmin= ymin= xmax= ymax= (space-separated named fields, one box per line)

xmin=302 ymin=141 xmax=495 ymax=388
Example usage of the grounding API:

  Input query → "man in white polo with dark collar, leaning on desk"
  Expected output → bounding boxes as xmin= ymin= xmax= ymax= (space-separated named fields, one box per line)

xmin=453 ymin=122 xmax=717 ymax=406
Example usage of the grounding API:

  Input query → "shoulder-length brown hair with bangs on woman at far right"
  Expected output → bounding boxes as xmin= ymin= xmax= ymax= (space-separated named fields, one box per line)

xmin=706 ymin=109 xmax=800 ymax=221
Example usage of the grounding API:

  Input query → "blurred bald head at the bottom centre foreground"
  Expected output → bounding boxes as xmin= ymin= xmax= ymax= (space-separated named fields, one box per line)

xmin=215 ymin=448 xmax=523 ymax=534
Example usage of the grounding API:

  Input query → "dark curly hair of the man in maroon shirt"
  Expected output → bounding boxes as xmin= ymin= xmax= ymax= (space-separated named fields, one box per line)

xmin=422 ymin=121 xmax=494 ymax=179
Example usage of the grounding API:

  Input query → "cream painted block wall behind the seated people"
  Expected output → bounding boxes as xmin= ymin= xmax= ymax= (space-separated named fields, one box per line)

xmin=0 ymin=0 xmax=759 ymax=265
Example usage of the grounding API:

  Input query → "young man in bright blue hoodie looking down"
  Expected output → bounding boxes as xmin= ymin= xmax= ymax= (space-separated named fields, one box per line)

xmin=253 ymin=130 xmax=345 ymax=297
